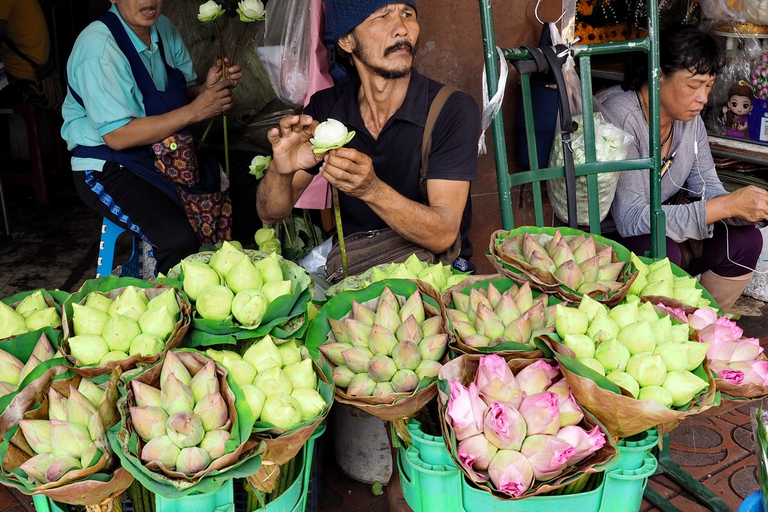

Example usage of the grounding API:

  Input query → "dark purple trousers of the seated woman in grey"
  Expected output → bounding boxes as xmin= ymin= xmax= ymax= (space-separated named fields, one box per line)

xmin=604 ymin=222 xmax=763 ymax=277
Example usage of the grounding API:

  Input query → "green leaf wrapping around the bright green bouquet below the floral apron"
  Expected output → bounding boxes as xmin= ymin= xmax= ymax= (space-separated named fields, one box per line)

xmin=164 ymin=249 xmax=315 ymax=348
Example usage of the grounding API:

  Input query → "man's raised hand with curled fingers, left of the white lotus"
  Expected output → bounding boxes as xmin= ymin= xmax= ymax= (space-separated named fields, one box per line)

xmin=267 ymin=115 xmax=323 ymax=175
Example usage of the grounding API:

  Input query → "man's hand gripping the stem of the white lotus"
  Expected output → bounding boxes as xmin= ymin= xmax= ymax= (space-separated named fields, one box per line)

xmin=320 ymin=148 xmax=381 ymax=201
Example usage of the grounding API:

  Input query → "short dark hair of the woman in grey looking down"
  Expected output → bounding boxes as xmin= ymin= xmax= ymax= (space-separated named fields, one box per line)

xmin=622 ymin=25 xmax=724 ymax=90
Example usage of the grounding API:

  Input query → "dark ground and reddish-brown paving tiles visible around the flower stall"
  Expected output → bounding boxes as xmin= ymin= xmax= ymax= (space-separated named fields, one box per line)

xmin=0 ymin=178 xmax=768 ymax=512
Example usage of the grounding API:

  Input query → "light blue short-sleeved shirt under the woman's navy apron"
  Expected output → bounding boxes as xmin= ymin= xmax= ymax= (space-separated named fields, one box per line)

xmin=61 ymin=5 xmax=197 ymax=171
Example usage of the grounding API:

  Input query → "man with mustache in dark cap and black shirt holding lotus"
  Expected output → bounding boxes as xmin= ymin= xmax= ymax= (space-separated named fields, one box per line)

xmin=257 ymin=0 xmax=479 ymax=278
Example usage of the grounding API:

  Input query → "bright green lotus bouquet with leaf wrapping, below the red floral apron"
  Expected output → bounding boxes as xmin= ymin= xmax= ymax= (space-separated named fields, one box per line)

xmin=161 ymin=242 xmax=314 ymax=347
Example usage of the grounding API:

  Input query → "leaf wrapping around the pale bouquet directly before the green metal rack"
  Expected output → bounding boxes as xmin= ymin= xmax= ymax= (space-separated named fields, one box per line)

xmin=486 ymin=226 xmax=637 ymax=307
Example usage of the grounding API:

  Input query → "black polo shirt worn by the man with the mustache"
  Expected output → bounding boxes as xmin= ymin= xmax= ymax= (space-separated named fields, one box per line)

xmin=304 ymin=69 xmax=480 ymax=254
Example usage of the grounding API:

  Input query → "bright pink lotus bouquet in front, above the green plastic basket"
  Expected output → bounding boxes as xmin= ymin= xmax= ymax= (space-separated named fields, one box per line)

xmin=438 ymin=354 xmax=617 ymax=499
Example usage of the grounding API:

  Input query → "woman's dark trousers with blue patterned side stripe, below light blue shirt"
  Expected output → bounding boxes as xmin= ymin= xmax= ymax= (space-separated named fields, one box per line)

xmin=74 ymin=164 xmax=200 ymax=274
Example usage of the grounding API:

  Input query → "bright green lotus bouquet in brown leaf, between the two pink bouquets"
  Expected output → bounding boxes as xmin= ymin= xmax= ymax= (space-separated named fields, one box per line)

xmin=547 ymin=297 xmax=716 ymax=437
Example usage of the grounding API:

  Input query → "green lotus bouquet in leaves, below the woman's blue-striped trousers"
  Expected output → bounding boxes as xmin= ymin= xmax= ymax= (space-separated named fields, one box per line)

xmin=62 ymin=276 xmax=190 ymax=377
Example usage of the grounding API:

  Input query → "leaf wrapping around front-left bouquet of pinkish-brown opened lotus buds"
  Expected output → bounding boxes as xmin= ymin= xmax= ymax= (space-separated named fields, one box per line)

xmin=107 ymin=349 xmax=264 ymax=499
